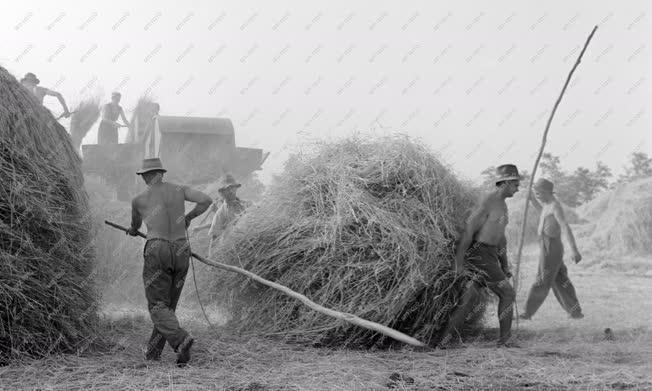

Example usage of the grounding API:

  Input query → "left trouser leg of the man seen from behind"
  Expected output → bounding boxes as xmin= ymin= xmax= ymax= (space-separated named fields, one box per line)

xmin=143 ymin=240 xmax=188 ymax=350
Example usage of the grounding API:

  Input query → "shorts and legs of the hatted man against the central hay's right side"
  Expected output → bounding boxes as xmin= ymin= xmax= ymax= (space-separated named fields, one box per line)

xmin=440 ymin=242 xmax=516 ymax=343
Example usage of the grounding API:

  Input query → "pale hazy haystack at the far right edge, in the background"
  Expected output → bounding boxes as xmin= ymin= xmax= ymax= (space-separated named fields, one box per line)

xmin=591 ymin=178 xmax=652 ymax=255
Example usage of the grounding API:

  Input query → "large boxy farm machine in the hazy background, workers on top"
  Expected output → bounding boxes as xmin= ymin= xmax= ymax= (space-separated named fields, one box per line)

xmin=82 ymin=115 xmax=269 ymax=201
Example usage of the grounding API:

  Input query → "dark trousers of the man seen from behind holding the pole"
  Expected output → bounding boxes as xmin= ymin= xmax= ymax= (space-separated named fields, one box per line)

xmin=143 ymin=239 xmax=190 ymax=358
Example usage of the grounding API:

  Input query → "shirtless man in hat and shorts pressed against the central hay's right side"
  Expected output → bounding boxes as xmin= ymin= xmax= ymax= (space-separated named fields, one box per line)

xmin=438 ymin=164 xmax=521 ymax=347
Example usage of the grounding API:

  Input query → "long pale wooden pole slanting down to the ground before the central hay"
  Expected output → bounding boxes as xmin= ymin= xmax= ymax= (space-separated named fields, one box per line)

xmin=104 ymin=220 xmax=426 ymax=347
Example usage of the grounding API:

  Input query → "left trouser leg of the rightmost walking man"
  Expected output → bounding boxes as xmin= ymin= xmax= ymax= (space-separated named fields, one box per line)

xmin=521 ymin=238 xmax=561 ymax=319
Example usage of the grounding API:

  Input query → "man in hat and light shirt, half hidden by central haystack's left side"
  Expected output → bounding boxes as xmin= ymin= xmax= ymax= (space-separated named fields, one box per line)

xmin=193 ymin=174 xmax=249 ymax=257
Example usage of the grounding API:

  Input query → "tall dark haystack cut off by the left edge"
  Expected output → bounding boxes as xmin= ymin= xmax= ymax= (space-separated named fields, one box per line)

xmin=0 ymin=67 xmax=97 ymax=362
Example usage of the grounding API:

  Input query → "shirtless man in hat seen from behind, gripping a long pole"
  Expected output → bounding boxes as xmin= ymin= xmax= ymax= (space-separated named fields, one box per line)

xmin=127 ymin=158 xmax=212 ymax=366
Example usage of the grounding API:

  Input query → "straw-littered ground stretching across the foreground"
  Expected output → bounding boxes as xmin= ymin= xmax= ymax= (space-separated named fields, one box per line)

xmin=0 ymin=249 xmax=652 ymax=391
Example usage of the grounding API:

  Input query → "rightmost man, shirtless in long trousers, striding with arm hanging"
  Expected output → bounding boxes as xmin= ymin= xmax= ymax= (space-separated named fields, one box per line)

xmin=520 ymin=178 xmax=584 ymax=320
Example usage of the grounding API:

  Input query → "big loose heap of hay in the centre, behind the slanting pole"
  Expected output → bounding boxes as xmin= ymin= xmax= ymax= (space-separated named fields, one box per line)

xmin=203 ymin=137 xmax=482 ymax=347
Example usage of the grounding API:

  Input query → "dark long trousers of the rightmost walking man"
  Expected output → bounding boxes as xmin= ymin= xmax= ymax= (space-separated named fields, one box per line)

xmin=524 ymin=235 xmax=582 ymax=317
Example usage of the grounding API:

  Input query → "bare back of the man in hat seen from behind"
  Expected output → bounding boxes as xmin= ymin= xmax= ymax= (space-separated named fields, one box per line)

xmin=135 ymin=182 xmax=186 ymax=240
